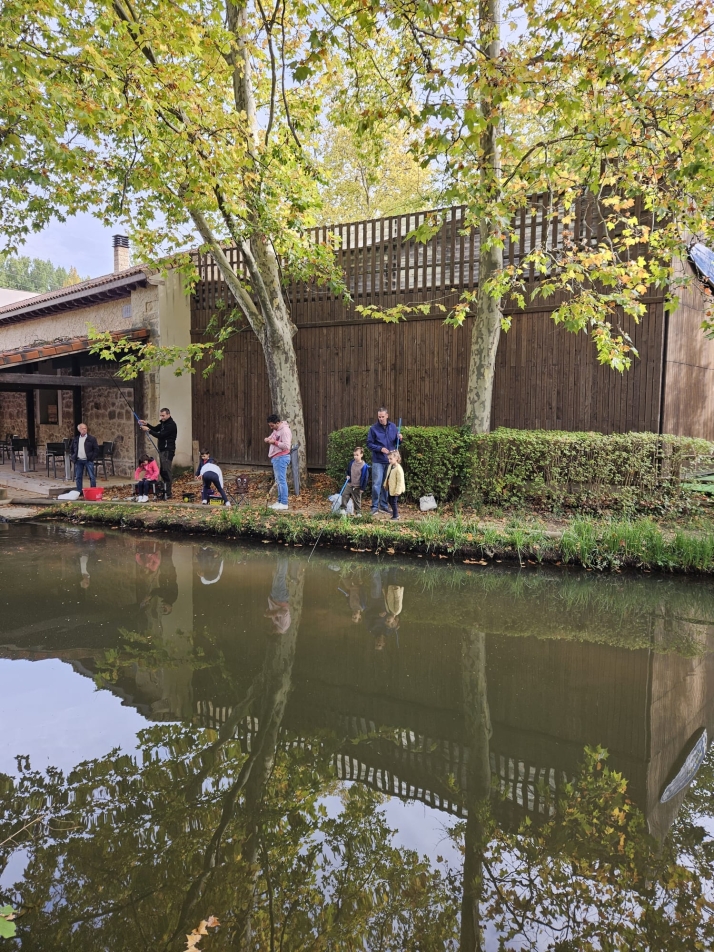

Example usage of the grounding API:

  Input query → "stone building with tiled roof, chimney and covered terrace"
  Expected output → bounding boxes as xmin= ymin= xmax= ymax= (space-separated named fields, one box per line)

xmin=0 ymin=235 xmax=192 ymax=476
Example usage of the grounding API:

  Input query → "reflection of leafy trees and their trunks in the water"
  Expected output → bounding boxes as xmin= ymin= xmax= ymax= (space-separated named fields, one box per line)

xmin=0 ymin=552 xmax=714 ymax=952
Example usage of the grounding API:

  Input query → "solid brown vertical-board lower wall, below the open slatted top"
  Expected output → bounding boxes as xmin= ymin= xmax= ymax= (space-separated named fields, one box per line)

xmin=193 ymin=304 xmax=663 ymax=467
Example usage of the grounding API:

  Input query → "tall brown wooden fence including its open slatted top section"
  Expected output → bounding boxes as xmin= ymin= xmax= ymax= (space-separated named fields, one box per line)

xmin=192 ymin=198 xmax=700 ymax=467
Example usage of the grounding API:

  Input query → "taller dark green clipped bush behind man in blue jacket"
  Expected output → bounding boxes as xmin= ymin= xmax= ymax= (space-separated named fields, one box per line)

xmin=327 ymin=426 xmax=474 ymax=501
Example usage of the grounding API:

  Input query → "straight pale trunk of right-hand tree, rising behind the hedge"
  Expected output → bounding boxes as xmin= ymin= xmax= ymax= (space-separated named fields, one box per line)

xmin=464 ymin=0 xmax=503 ymax=433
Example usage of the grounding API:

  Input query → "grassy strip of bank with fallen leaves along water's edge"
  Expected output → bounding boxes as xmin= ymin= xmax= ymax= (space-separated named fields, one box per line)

xmin=42 ymin=503 xmax=714 ymax=573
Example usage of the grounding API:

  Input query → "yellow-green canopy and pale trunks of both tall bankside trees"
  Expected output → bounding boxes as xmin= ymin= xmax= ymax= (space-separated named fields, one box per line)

xmin=0 ymin=0 xmax=714 ymax=446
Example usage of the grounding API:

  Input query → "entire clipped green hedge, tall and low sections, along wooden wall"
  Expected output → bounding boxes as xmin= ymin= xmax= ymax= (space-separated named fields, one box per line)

xmin=327 ymin=426 xmax=714 ymax=506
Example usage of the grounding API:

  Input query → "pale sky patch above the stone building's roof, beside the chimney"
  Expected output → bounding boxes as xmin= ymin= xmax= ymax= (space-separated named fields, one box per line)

xmin=18 ymin=214 xmax=124 ymax=278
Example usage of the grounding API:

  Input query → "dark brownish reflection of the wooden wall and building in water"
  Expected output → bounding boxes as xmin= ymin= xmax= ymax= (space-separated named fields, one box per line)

xmin=0 ymin=530 xmax=714 ymax=838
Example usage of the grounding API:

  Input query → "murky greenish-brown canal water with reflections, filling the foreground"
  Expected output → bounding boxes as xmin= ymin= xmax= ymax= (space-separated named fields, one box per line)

xmin=0 ymin=524 xmax=714 ymax=952
